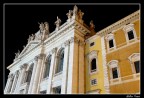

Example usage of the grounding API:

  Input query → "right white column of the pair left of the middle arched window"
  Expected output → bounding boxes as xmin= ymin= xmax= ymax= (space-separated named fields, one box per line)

xmin=31 ymin=54 xmax=45 ymax=94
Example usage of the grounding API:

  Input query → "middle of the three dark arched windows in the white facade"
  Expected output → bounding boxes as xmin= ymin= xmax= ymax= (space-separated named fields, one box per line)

xmin=44 ymin=55 xmax=51 ymax=78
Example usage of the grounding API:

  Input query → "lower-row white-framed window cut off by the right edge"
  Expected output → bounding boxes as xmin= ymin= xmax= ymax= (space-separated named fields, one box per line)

xmin=128 ymin=53 xmax=140 ymax=74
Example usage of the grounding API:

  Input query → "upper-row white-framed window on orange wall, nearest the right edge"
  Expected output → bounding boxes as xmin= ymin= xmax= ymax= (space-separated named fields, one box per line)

xmin=123 ymin=24 xmax=137 ymax=43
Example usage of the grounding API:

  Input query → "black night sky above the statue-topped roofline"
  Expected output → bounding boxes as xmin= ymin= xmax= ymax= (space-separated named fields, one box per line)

xmin=4 ymin=4 xmax=140 ymax=86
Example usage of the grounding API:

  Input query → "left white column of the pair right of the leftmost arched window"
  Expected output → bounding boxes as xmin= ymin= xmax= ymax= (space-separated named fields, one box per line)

xmin=28 ymin=56 xmax=38 ymax=94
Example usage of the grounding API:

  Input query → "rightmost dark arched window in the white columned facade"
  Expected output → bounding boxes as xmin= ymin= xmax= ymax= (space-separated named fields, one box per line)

xmin=55 ymin=49 xmax=64 ymax=73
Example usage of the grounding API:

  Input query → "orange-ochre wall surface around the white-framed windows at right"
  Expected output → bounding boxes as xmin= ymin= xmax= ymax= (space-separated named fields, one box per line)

xmin=105 ymin=21 xmax=140 ymax=93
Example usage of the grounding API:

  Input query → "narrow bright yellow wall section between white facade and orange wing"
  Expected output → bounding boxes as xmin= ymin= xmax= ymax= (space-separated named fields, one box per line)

xmin=85 ymin=37 xmax=105 ymax=93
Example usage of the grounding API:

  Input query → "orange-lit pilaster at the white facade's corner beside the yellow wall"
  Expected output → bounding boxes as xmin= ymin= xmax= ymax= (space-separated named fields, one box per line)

xmin=78 ymin=41 xmax=85 ymax=94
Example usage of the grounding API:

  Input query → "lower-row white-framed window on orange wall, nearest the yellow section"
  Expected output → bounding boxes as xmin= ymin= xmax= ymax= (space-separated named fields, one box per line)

xmin=108 ymin=60 xmax=120 ymax=79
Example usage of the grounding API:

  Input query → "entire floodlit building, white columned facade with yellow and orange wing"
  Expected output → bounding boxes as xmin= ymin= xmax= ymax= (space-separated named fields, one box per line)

xmin=4 ymin=6 xmax=140 ymax=94
